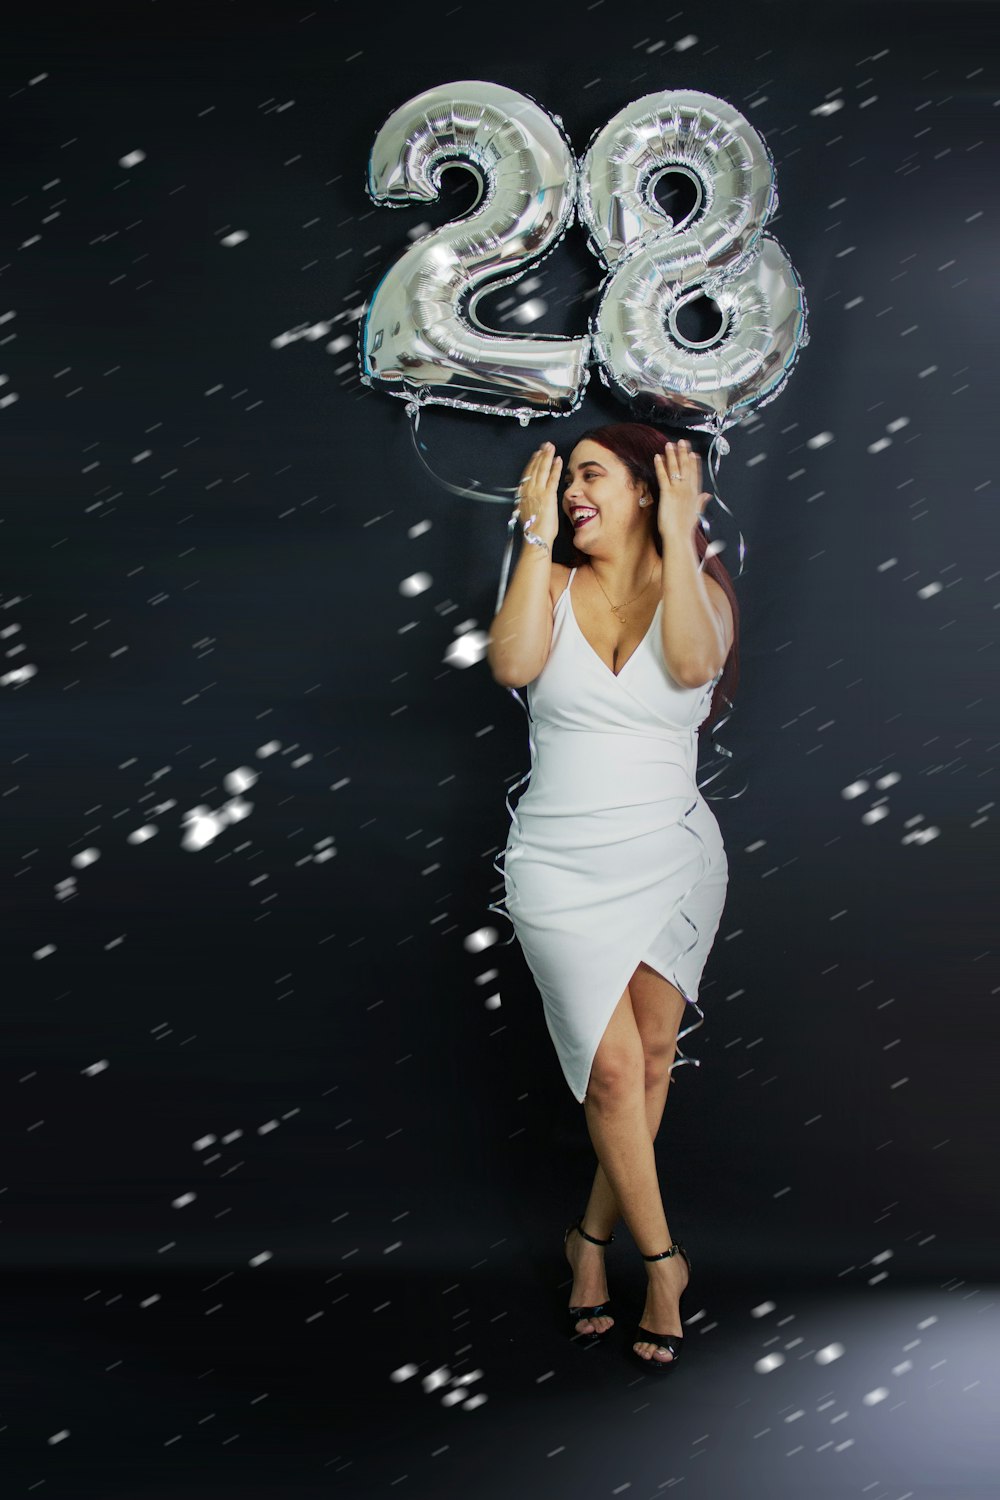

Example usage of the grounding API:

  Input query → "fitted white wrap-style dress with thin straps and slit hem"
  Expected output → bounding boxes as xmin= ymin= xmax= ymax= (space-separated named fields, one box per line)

xmin=490 ymin=569 xmax=729 ymax=1103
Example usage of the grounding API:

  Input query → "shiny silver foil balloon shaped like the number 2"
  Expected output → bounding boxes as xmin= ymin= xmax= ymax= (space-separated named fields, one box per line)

xmin=358 ymin=81 xmax=591 ymax=422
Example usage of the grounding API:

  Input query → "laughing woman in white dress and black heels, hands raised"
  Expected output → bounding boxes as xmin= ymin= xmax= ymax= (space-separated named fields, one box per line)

xmin=487 ymin=423 xmax=739 ymax=1368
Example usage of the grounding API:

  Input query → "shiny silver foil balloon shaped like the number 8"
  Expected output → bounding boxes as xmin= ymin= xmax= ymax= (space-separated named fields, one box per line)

xmin=580 ymin=90 xmax=808 ymax=434
